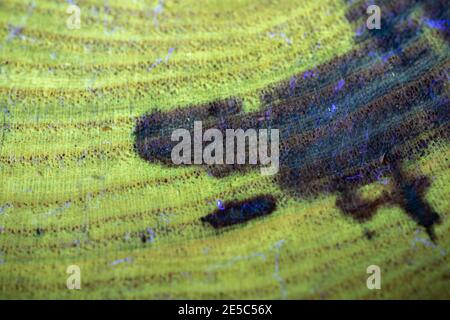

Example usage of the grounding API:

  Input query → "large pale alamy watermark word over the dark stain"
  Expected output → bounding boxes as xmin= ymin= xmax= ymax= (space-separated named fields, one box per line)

xmin=171 ymin=121 xmax=280 ymax=175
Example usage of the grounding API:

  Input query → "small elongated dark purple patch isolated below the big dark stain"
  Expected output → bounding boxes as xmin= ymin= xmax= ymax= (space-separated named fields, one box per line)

xmin=201 ymin=195 xmax=276 ymax=229
